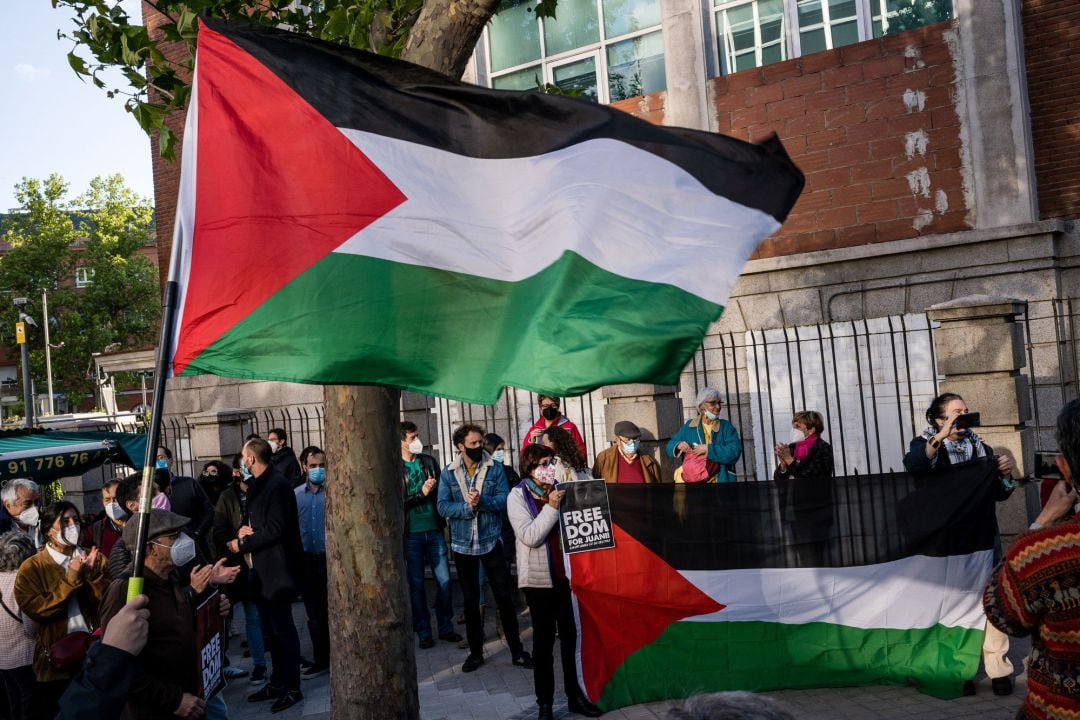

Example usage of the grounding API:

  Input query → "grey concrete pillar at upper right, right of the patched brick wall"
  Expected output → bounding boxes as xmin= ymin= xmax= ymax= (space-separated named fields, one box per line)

xmin=954 ymin=0 xmax=1039 ymax=229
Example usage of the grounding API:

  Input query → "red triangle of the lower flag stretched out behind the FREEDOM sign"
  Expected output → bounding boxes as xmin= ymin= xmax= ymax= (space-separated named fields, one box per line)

xmin=570 ymin=524 xmax=725 ymax=702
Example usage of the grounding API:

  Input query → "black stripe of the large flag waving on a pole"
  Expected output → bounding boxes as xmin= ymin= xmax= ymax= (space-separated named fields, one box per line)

xmin=203 ymin=18 xmax=805 ymax=222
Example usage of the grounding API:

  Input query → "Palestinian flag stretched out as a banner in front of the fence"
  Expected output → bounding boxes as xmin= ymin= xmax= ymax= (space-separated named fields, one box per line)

xmin=566 ymin=461 xmax=999 ymax=709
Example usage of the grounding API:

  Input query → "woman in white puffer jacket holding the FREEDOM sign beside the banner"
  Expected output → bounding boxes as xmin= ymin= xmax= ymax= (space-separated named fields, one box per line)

xmin=507 ymin=445 xmax=602 ymax=720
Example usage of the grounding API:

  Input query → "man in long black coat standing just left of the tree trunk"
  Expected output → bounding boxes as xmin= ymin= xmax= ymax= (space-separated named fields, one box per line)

xmin=228 ymin=438 xmax=303 ymax=712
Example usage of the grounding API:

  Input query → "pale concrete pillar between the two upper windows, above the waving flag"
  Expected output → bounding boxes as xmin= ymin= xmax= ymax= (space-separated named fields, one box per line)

xmin=660 ymin=0 xmax=715 ymax=130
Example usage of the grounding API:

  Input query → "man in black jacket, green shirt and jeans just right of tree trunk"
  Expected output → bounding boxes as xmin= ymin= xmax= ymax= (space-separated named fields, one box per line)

xmin=401 ymin=421 xmax=461 ymax=649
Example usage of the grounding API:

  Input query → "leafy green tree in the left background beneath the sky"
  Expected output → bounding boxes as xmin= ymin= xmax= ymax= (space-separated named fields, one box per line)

xmin=0 ymin=175 xmax=161 ymax=404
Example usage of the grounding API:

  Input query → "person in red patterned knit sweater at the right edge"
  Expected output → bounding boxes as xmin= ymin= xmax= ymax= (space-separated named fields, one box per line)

xmin=983 ymin=400 xmax=1080 ymax=720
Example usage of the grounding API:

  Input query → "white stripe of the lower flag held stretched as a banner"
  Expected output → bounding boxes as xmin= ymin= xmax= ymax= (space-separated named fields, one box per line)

xmin=681 ymin=551 xmax=994 ymax=629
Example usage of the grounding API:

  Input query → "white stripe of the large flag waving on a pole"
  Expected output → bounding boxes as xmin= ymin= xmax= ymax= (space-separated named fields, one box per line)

xmin=336 ymin=128 xmax=780 ymax=304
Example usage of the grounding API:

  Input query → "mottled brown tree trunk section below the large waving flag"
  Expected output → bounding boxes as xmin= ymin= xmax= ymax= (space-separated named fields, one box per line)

xmin=326 ymin=385 xmax=420 ymax=720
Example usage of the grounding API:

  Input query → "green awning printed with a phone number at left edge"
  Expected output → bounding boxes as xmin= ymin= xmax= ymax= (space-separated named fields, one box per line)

xmin=0 ymin=431 xmax=146 ymax=483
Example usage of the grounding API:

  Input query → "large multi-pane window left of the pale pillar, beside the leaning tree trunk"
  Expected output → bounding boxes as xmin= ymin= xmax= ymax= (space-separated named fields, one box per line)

xmin=485 ymin=0 xmax=666 ymax=103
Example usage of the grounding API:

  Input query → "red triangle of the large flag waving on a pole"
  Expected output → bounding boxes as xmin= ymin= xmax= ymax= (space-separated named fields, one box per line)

xmin=173 ymin=25 xmax=406 ymax=375
